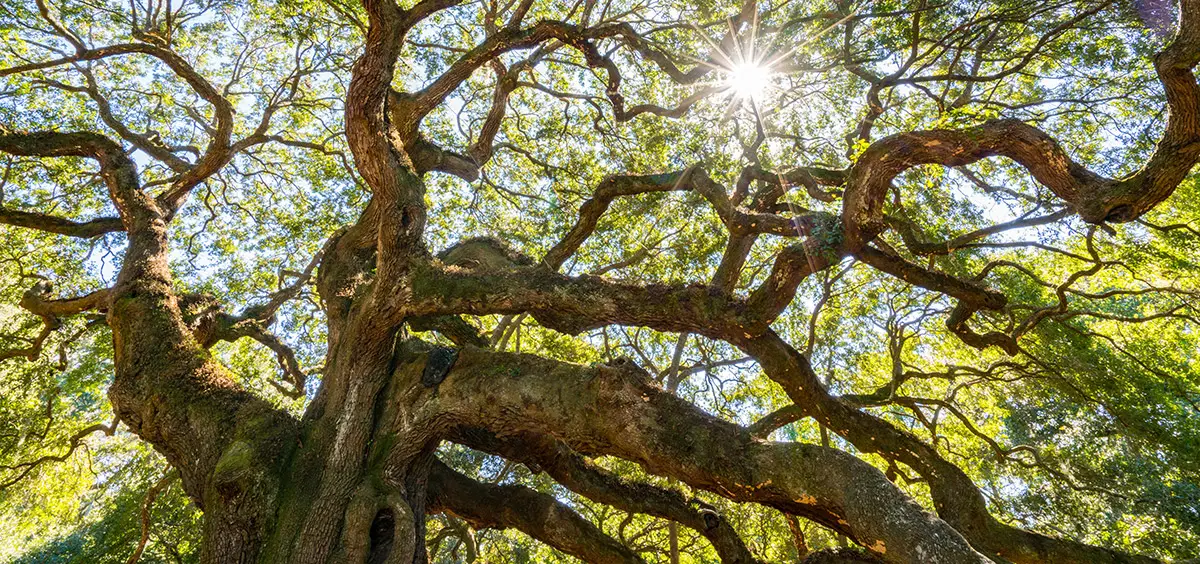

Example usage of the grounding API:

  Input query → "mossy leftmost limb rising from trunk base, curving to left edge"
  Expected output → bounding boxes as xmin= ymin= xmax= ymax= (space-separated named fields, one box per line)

xmin=0 ymin=130 xmax=295 ymax=564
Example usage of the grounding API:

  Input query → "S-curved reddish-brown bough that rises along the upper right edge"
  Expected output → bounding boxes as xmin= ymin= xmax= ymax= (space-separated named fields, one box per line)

xmin=842 ymin=0 xmax=1200 ymax=251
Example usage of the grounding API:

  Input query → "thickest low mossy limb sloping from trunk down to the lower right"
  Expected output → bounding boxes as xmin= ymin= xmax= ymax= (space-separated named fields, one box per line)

xmin=389 ymin=348 xmax=986 ymax=563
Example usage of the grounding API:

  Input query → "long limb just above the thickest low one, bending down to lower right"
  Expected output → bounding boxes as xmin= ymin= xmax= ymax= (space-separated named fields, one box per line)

xmin=414 ymin=255 xmax=1156 ymax=562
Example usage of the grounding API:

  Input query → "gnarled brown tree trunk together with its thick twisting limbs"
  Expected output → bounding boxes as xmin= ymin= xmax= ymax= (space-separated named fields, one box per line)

xmin=0 ymin=0 xmax=1200 ymax=564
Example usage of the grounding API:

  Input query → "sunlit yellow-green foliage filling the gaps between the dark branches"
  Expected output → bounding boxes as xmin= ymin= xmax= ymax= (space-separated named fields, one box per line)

xmin=0 ymin=0 xmax=1200 ymax=563
